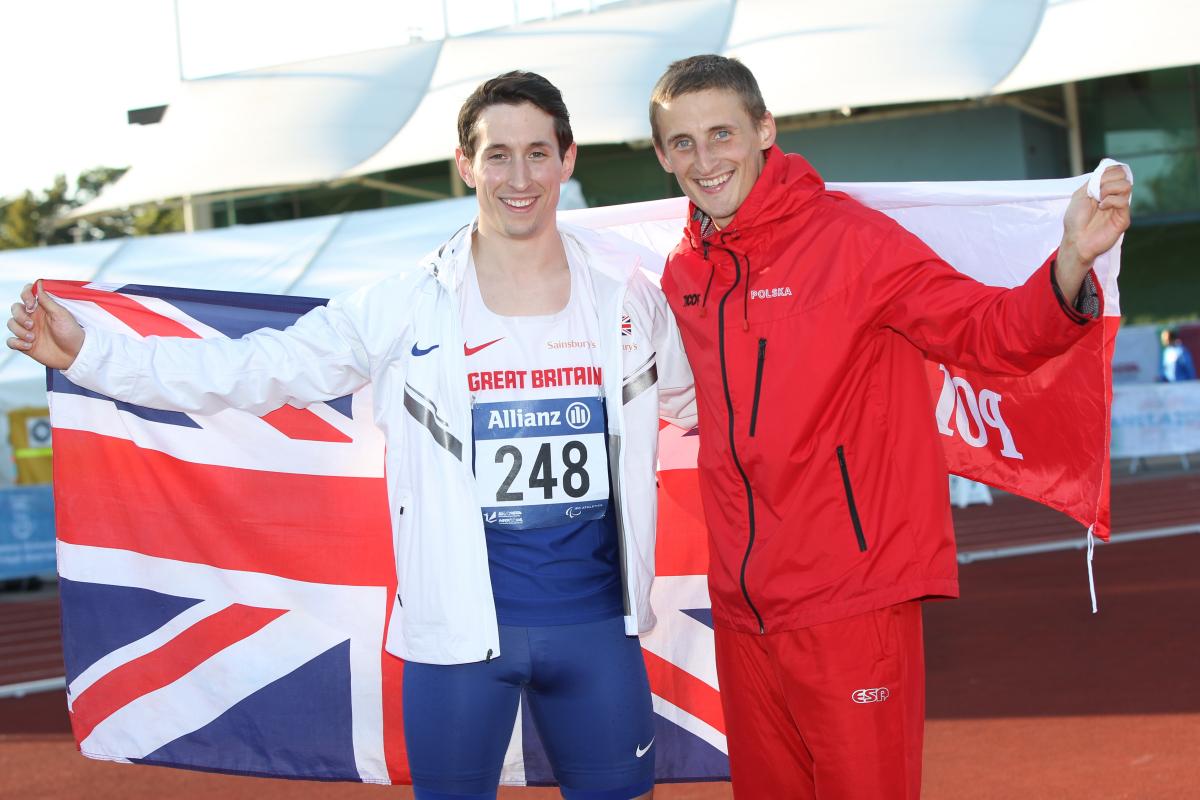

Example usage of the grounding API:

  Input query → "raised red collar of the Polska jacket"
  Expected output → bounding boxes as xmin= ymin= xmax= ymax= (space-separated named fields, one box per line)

xmin=686 ymin=145 xmax=824 ymax=252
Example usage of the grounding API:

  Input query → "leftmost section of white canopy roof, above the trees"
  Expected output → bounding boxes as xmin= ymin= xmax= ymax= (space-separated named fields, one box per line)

xmin=76 ymin=42 xmax=442 ymax=216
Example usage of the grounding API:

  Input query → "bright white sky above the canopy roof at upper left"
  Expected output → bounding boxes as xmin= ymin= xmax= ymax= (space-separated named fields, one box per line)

xmin=0 ymin=0 xmax=612 ymax=198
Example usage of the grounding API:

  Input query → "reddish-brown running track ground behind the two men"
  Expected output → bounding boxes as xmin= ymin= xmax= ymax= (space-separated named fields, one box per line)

xmin=0 ymin=476 xmax=1200 ymax=800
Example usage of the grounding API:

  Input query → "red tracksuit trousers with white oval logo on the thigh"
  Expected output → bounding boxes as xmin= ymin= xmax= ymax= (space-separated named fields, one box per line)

xmin=716 ymin=600 xmax=925 ymax=800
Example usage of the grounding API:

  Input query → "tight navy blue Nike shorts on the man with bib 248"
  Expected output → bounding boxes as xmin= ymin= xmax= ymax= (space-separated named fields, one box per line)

xmin=403 ymin=616 xmax=655 ymax=800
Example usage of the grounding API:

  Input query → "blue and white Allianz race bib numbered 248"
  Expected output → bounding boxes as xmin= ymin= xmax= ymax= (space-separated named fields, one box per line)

xmin=472 ymin=397 xmax=608 ymax=530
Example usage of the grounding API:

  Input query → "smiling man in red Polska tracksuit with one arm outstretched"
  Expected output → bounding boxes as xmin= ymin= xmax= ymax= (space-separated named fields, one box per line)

xmin=650 ymin=55 xmax=1130 ymax=800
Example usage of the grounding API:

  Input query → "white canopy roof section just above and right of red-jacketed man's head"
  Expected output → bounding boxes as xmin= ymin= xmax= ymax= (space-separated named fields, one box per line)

xmin=724 ymin=0 xmax=1044 ymax=116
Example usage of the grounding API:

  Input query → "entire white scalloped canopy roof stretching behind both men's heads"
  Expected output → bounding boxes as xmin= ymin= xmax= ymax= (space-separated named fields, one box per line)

xmin=76 ymin=0 xmax=1200 ymax=216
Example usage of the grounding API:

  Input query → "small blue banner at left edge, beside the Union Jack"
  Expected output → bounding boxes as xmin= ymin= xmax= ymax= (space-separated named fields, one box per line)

xmin=0 ymin=486 xmax=54 ymax=581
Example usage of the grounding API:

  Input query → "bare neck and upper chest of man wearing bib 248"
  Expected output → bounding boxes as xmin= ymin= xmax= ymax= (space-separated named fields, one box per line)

xmin=470 ymin=228 xmax=571 ymax=317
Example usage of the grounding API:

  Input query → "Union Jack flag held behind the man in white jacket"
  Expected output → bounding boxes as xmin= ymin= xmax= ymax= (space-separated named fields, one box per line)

xmin=42 ymin=281 xmax=728 ymax=784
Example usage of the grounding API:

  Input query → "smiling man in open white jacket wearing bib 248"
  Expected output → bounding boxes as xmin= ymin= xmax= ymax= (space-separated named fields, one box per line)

xmin=8 ymin=72 xmax=694 ymax=800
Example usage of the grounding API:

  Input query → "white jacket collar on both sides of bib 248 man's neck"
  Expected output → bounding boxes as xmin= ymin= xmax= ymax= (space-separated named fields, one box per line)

xmin=421 ymin=217 xmax=661 ymax=293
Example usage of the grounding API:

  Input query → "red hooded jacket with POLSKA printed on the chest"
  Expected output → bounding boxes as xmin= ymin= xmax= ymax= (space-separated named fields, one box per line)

xmin=662 ymin=148 xmax=1093 ymax=632
